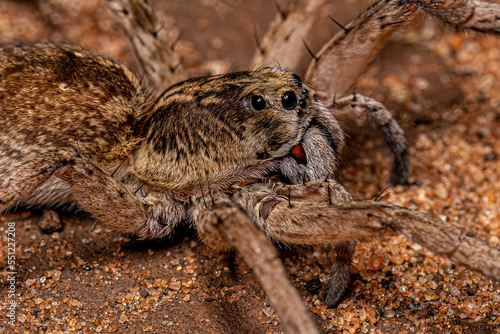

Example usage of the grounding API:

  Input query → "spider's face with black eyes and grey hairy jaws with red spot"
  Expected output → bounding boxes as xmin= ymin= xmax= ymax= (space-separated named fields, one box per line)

xmin=233 ymin=69 xmax=344 ymax=184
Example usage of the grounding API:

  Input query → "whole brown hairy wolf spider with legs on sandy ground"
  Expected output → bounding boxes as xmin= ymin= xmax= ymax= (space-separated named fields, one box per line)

xmin=0 ymin=0 xmax=500 ymax=333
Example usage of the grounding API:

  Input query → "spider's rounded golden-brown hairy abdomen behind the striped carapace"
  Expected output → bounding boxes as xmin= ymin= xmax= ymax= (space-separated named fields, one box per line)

xmin=0 ymin=43 xmax=150 ymax=206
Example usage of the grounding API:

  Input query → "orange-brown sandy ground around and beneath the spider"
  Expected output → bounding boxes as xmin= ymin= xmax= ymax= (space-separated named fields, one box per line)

xmin=0 ymin=0 xmax=500 ymax=333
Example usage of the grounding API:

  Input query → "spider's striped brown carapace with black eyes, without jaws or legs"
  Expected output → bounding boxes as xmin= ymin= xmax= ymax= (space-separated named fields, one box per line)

xmin=135 ymin=68 xmax=342 ymax=190
